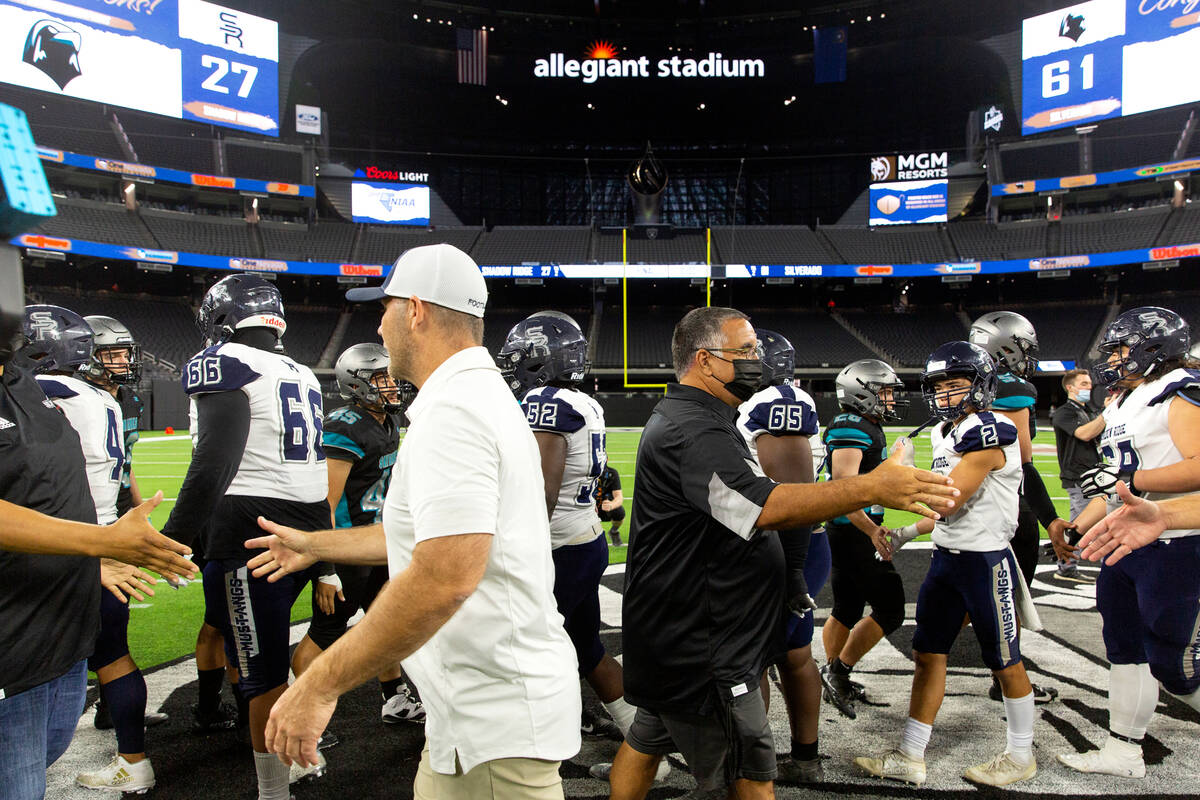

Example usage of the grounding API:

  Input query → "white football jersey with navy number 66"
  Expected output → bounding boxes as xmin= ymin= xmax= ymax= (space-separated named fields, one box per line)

xmin=184 ymin=343 xmax=329 ymax=503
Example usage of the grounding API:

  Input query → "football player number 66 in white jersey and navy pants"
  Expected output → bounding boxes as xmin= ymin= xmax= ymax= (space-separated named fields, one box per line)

xmin=164 ymin=275 xmax=329 ymax=800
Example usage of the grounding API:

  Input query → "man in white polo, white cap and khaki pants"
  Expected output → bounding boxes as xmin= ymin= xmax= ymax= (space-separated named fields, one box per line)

xmin=247 ymin=245 xmax=581 ymax=800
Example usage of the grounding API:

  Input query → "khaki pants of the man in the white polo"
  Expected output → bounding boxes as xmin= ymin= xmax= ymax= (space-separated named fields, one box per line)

xmin=413 ymin=742 xmax=563 ymax=800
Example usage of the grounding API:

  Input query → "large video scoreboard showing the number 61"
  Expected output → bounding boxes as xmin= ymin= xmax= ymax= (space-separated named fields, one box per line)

xmin=1021 ymin=0 xmax=1200 ymax=134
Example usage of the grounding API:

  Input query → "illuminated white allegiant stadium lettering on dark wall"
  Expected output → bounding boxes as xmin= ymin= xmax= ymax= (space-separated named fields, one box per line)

xmin=533 ymin=53 xmax=767 ymax=83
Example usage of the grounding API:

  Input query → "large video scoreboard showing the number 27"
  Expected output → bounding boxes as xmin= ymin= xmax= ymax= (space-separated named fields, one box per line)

xmin=0 ymin=0 xmax=280 ymax=136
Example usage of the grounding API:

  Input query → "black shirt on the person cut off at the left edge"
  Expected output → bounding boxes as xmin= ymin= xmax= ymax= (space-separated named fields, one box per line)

xmin=0 ymin=363 xmax=101 ymax=697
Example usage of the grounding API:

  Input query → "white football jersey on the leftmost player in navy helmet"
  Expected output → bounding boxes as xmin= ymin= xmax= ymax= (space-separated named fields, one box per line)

xmin=37 ymin=375 xmax=126 ymax=525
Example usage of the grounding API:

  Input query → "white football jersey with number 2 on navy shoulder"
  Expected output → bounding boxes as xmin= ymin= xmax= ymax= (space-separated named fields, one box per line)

xmin=930 ymin=411 xmax=1021 ymax=553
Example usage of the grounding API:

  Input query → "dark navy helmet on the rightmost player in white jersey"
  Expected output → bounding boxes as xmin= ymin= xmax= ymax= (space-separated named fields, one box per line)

xmin=1093 ymin=306 xmax=1192 ymax=386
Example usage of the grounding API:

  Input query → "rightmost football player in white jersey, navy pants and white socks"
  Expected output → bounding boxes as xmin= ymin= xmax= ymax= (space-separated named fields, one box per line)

xmin=1058 ymin=306 xmax=1200 ymax=777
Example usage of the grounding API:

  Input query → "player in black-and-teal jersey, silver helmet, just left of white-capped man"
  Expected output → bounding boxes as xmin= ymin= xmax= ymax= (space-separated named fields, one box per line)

xmin=292 ymin=343 xmax=425 ymax=734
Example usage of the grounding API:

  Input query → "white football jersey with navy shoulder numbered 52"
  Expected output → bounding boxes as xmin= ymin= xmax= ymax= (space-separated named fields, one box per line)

xmin=521 ymin=386 xmax=608 ymax=548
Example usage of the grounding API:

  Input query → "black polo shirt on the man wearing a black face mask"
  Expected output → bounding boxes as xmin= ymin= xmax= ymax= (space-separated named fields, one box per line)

xmin=622 ymin=384 xmax=786 ymax=714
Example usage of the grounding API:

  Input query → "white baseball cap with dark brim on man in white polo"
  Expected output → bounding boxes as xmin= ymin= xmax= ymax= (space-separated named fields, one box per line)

xmin=346 ymin=245 xmax=487 ymax=317
